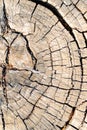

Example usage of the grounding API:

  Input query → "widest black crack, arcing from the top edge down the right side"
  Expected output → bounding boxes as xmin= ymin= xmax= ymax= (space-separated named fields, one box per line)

xmin=31 ymin=0 xmax=83 ymax=101
